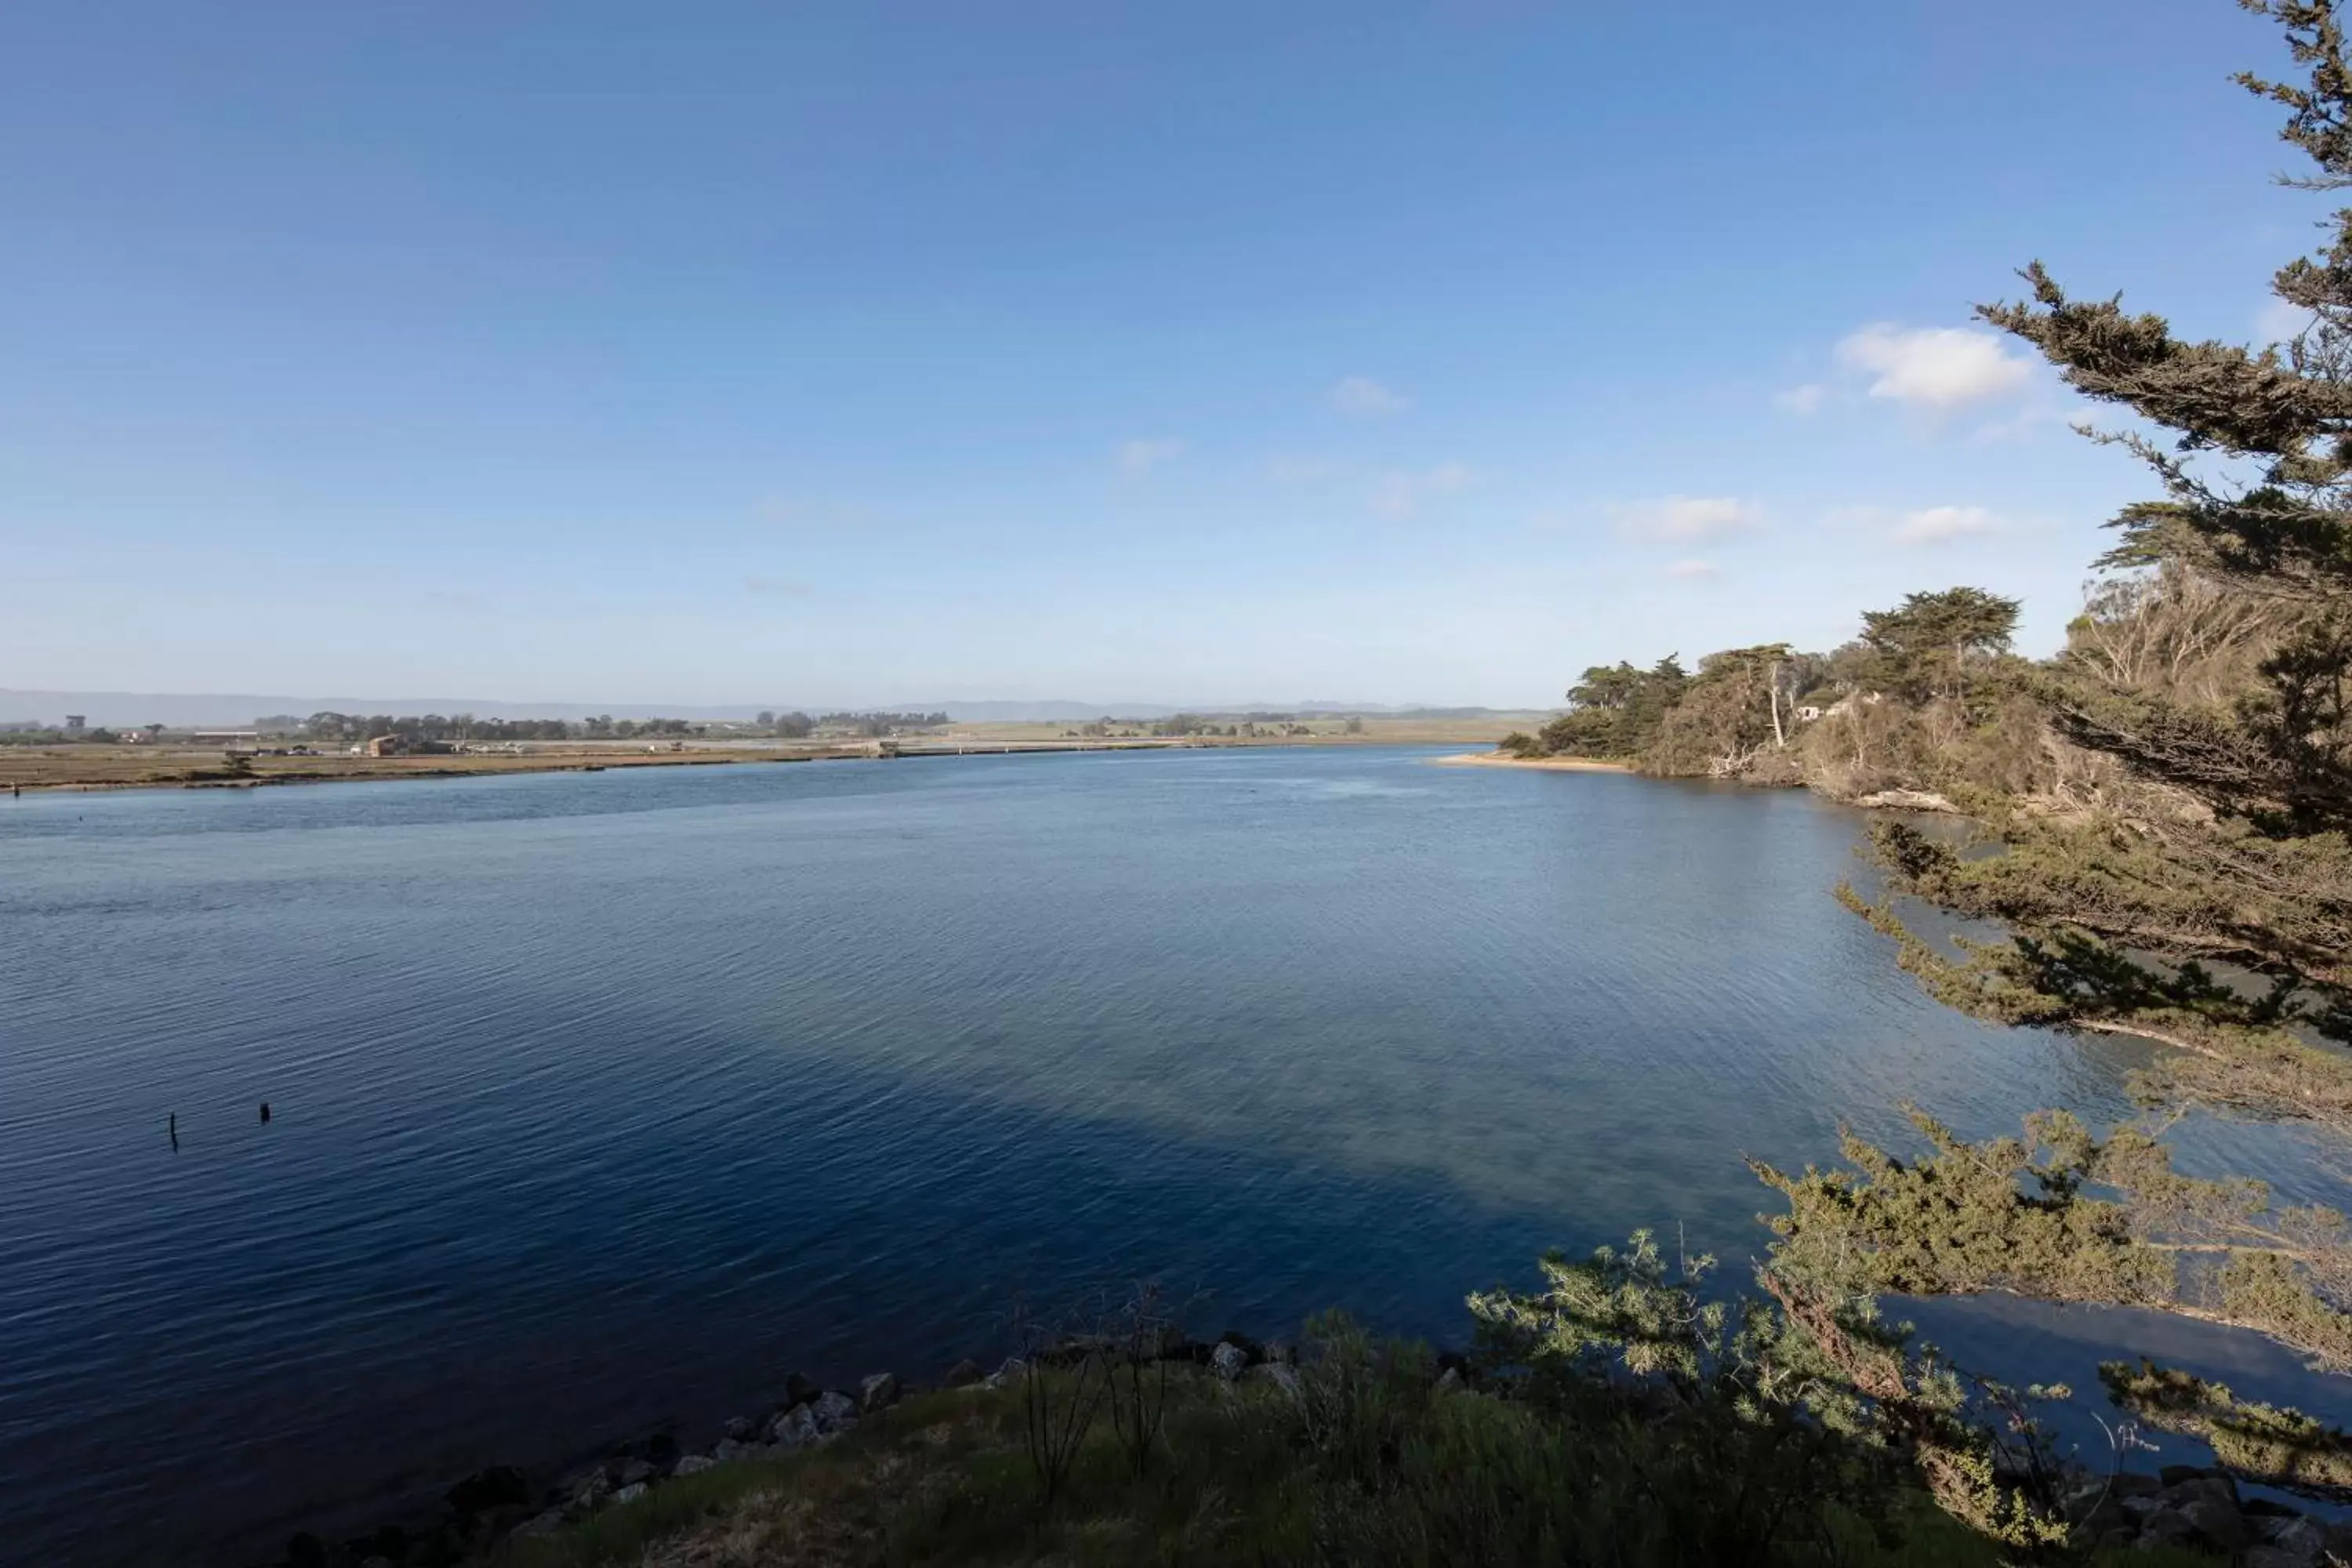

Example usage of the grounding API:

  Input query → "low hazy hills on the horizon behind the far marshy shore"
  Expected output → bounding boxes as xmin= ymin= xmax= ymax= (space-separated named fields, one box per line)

xmin=0 ymin=687 xmax=1517 ymax=729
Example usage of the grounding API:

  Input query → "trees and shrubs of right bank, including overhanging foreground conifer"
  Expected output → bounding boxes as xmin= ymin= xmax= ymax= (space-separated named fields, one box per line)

xmin=1486 ymin=0 xmax=2352 ymax=1561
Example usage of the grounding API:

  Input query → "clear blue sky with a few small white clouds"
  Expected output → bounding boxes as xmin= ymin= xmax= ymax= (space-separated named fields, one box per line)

xmin=0 ymin=0 xmax=2324 ymax=706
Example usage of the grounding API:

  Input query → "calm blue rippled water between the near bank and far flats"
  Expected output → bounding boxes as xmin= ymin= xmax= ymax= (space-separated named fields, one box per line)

xmin=0 ymin=750 xmax=2326 ymax=1561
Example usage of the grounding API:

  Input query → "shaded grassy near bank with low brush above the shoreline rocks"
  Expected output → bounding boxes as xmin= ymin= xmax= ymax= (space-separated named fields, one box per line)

xmin=501 ymin=1370 xmax=2213 ymax=1568
